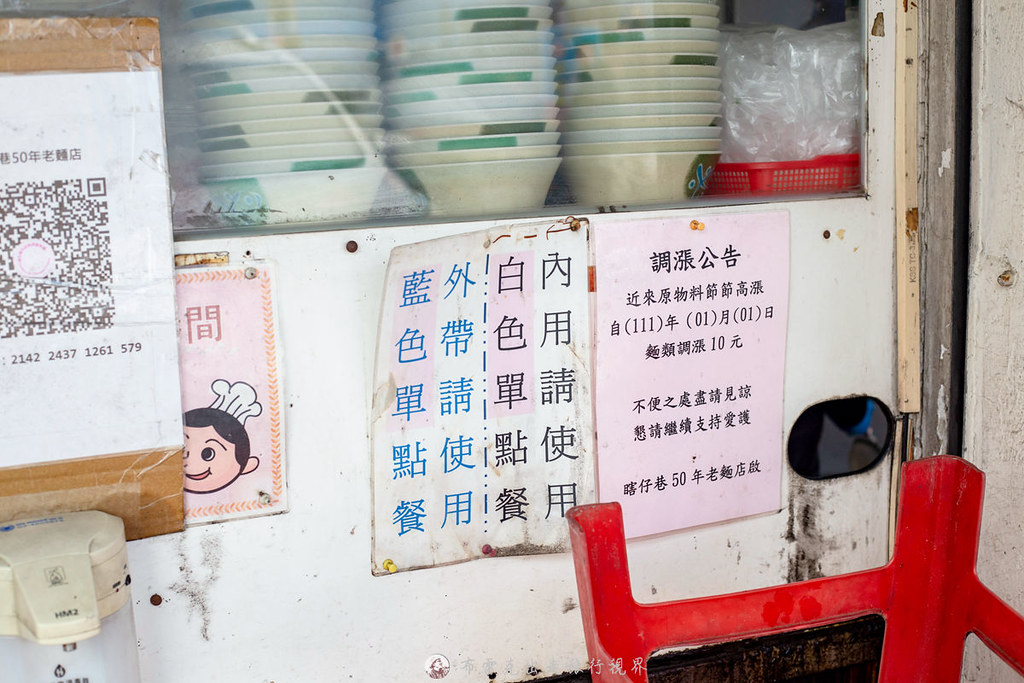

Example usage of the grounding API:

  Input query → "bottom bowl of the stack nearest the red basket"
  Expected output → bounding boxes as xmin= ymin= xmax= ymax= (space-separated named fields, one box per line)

xmin=564 ymin=152 xmax=720 ymax=206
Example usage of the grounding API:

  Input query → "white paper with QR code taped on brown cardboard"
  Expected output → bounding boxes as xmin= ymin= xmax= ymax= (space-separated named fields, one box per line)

xmin=0 ymin=70 xmax=181 ymax=466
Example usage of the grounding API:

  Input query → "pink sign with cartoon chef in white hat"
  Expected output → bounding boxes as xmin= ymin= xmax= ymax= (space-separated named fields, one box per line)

xmin=176 ymin=263 xmax=288 ymax=524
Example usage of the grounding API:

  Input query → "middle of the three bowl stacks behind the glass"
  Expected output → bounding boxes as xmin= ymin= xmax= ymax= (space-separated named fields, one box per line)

xmin=378 ymin=0 xmax=561 ymax=216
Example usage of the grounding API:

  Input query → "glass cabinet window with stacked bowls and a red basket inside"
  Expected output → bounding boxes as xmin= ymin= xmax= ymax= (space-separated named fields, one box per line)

xmin=0 ymin=0 xmax=863 ymax=233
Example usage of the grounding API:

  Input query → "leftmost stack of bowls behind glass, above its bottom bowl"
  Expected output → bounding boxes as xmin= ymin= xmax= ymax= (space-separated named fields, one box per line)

xmin=183 ymin=0 xmax=383 ymax=196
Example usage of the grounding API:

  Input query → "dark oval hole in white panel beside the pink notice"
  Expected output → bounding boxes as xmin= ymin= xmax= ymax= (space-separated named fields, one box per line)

xmin=786 ymin=396 xmax=894 ymax=479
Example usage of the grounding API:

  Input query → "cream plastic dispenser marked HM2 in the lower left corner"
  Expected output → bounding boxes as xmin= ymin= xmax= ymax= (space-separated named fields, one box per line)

xmin=0 ymin=511 xmax=139 ymax=683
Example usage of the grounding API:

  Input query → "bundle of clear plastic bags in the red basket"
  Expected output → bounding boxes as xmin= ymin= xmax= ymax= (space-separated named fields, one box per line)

xmin=719 ymin=18 xmax=863 ymax=163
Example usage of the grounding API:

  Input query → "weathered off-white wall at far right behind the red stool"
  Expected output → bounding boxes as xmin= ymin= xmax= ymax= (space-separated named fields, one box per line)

xmin=964 ymin=0 xmax=1024 ymax=683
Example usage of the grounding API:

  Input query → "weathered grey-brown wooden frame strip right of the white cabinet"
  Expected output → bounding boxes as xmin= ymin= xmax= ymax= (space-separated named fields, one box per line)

xmin=917 ymin=0 xmax=973 ymax=457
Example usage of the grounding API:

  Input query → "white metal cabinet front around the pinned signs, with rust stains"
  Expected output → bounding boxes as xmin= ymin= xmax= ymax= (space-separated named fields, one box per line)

xmin=123 ymin=0 xmax=901 ymax=683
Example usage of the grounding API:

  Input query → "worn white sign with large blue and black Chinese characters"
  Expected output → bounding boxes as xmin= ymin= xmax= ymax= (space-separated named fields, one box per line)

xmin=371 ymin=219 xmax=595 ymax=574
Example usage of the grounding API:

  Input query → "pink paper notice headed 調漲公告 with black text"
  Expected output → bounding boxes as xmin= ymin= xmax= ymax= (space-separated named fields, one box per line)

xmin=594 ymin=212 xmax=790 ymax=538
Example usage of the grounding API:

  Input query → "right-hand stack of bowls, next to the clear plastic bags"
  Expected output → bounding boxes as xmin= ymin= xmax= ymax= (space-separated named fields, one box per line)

xmin=557 ymin=0 xmax=722 ymax=206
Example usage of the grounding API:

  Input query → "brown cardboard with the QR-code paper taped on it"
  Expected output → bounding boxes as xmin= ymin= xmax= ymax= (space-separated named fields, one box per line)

xmin=0 ymin=18 xmax=183 ymax=539
